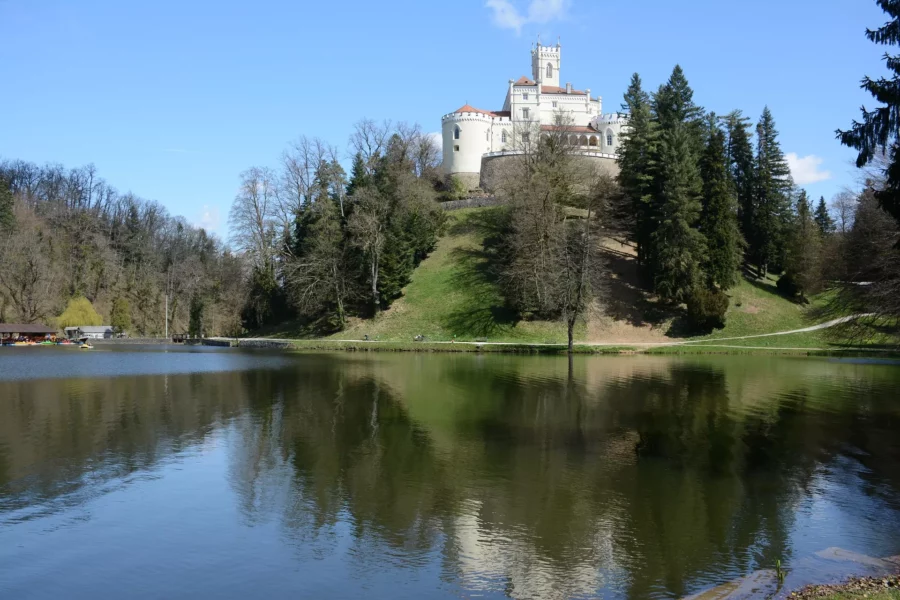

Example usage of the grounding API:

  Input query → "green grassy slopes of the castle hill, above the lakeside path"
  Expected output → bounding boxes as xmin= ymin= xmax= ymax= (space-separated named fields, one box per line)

xmin=262 ymin=208 xmax=892 ymax=348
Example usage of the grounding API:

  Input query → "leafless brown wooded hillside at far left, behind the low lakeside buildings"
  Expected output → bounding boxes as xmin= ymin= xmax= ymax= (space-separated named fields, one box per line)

xmin=0 ymin=160 xmax=246 ymax=336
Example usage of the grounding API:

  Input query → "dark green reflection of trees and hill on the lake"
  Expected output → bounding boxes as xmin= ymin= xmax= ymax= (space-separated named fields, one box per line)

xmin=0 ymin=355 xmax=900 ymax=598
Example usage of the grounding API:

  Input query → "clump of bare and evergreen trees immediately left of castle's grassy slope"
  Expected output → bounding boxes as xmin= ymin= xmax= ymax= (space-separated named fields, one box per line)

xmin=229 ymin=119 xmax=444 ymax=333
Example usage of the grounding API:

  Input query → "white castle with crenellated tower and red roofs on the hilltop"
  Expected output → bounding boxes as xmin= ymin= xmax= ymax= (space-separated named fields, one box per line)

xmin=441 ymin=39 xmax=627 ymax=188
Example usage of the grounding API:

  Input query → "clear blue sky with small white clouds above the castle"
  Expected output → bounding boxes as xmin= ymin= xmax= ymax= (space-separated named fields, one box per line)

xmin=0 ymin=0 xmax=885 ymax=236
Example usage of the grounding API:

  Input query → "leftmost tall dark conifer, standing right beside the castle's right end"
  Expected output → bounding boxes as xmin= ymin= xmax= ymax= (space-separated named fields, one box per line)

xmin=619 ymin=73 xmax=656 ymax=266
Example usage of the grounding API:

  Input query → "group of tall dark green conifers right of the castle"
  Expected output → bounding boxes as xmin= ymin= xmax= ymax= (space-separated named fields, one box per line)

xmin=618 ymin=66 xmax=856 ymax=329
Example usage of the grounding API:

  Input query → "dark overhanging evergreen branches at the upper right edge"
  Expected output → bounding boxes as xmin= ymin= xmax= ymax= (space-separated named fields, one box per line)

xmin=836 ymin=0 xmax=900 ymax=222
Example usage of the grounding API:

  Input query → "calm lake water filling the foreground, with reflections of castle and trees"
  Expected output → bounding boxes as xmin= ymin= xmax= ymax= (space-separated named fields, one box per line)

xmin=0 ymin=347 xmax=900 ymax=599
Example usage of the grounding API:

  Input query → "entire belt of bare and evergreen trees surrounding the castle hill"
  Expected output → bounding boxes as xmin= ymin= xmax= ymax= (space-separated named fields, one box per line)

xmin=0 ymin=3 xmax=900 ymax=345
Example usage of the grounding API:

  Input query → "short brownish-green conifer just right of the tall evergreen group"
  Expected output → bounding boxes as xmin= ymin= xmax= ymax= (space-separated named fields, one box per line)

xmin=778 ymin=190 xmax=822 ymax=299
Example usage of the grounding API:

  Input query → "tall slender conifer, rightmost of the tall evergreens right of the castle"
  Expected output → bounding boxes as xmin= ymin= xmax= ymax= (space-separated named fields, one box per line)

xmin=748 ymin=106 xmax=793 ymax=277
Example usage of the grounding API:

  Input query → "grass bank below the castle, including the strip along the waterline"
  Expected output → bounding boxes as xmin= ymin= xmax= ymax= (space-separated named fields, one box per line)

xmin=257 ymin=208 xmax=900 ymax=354
